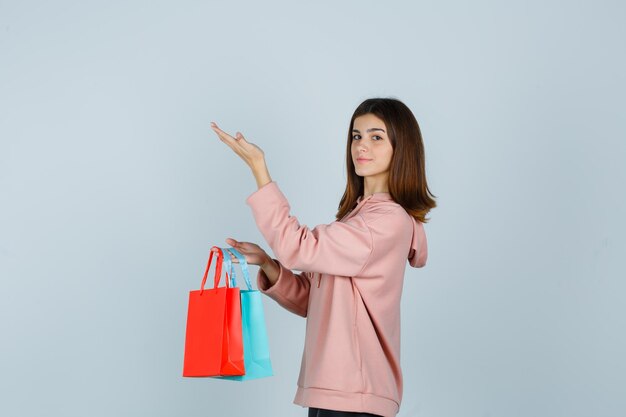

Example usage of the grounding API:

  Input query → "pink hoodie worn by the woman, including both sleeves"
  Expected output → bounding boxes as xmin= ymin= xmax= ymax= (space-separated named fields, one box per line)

xmin=246 ymin=181 xmax=428 ymax=417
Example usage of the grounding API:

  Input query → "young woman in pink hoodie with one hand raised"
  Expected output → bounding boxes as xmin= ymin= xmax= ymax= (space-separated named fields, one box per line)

xmin=212 ymin=98 xmax=436 ymax=417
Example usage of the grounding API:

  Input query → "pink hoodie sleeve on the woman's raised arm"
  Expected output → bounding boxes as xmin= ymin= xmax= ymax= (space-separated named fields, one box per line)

xmin=246 ymin=181 xmax=373 ymax=277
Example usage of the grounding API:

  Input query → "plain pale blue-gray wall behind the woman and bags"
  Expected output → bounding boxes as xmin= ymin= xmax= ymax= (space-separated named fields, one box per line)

xmin=0 ymin=0 xmax=626 ymax=417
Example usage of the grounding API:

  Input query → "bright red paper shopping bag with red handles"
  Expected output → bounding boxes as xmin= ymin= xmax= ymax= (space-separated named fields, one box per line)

xmin=183 ymin=246 xmax=245 ymax=377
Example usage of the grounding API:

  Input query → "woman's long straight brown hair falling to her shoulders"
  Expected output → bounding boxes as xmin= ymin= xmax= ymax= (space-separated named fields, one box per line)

xmin=335 ymin=98 xmax=437 ymax=223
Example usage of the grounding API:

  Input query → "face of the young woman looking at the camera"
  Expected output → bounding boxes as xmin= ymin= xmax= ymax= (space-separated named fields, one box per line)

xmin=351 ymin=113 xmax=393 ymax=177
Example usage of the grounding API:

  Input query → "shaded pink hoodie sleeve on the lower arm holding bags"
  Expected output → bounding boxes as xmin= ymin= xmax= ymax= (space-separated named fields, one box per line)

xmin=257 ymin=255 xmax=311 ymax=317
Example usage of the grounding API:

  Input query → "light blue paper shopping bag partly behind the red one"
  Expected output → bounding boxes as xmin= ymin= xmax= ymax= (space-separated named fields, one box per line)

xmin=217 ymin=247 xmax=274 ymax=381
